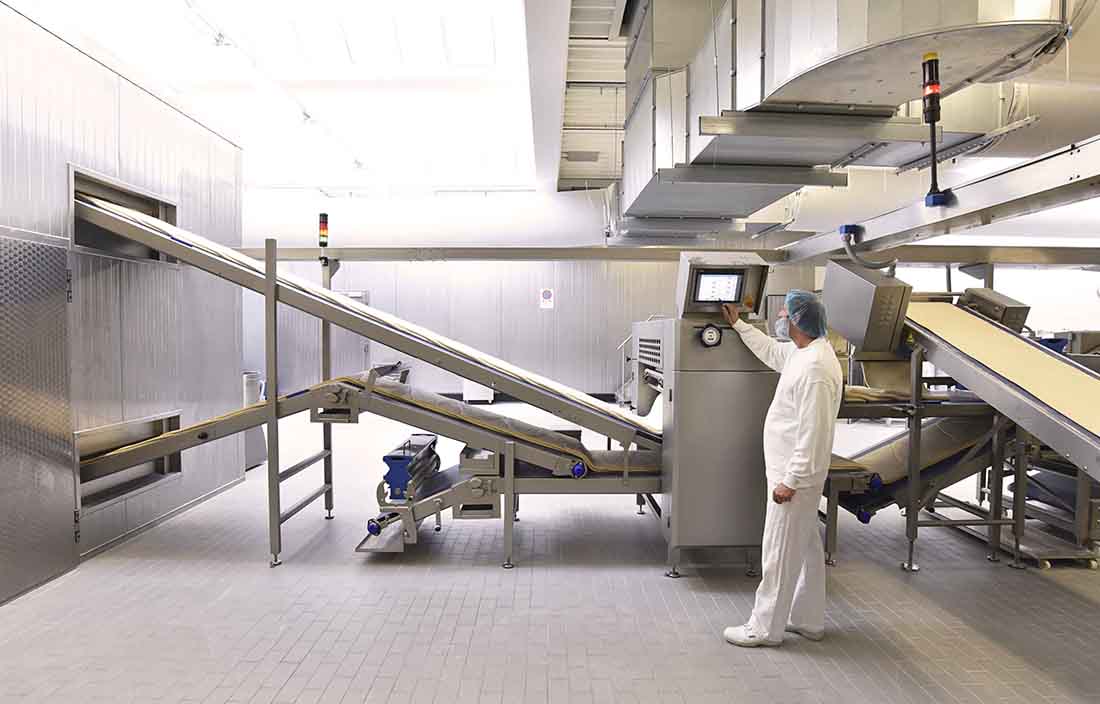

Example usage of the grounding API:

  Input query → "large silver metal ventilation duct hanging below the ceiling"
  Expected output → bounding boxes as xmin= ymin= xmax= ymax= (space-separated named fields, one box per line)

xmin=622 ymin=0 xmax=1100 ymax=239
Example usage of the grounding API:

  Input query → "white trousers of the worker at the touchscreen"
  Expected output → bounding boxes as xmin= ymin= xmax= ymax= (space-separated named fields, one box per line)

xmin=749 ymin=487 xmax=825 ymax=642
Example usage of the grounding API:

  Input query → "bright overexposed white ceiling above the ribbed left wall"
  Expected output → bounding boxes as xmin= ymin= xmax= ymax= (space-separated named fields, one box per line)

xmin=12 ymin=0 xmax=535 ymax=189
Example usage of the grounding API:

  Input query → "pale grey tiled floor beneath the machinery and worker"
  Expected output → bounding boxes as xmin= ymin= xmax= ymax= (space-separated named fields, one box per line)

xmin=0 ymin=409 xmax=1100 ymax=703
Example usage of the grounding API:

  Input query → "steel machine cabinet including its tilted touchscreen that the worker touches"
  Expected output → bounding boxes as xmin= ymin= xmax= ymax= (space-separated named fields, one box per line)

xmin=633 ymin=253 xmax=779 ymax=576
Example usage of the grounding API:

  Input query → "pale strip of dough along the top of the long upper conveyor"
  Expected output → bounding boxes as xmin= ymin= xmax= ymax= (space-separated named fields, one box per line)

xmin=79 ymin=194 xmax=662 ymax=438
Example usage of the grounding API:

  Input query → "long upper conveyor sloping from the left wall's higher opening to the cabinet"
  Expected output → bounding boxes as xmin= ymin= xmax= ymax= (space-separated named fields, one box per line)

xmin=74 ymin=193 xmax=661 ymax=449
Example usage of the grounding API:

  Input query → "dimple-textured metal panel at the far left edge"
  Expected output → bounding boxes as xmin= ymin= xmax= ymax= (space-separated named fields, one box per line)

xmin=0 ymin=238 xmax=76 ymax=602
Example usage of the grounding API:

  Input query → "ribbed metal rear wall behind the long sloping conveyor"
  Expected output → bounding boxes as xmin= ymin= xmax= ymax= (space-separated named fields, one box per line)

xmin=244 ymin=262 xmax=677 ymax=394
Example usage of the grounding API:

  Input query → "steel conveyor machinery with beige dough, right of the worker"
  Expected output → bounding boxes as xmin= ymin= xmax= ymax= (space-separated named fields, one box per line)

xmin=825 ymin=262 xmax=1100 ymax=570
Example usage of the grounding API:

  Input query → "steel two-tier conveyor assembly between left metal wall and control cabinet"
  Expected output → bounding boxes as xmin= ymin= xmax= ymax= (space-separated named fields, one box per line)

xmin=74 ymin=194 xmax=661 ymax=568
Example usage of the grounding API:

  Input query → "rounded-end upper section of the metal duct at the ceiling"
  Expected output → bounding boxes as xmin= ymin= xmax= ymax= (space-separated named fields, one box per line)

xmin=736 ymin=0 xmax=1066 ymax=114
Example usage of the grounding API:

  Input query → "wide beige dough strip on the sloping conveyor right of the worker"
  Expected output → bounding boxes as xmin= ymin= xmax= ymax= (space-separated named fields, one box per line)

xmin=905 ymin=303 xmax=1100 ymax=436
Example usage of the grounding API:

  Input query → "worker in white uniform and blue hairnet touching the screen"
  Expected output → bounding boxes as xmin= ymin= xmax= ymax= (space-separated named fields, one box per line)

xmin=723 ymin=290 xmax=844 ymax=648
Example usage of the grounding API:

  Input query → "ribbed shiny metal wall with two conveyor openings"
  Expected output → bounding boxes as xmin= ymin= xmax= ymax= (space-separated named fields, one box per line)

xmin=0 ymin=6 xmax=244 ymax=567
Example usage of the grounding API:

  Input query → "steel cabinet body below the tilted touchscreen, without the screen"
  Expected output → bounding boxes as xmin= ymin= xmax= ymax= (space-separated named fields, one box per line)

xmin=634 ymin=318 xmax=779 ymax=565
